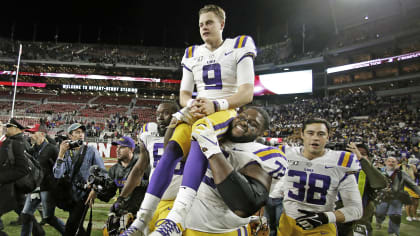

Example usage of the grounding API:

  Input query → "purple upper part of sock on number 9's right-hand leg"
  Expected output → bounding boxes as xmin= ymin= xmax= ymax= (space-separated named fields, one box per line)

xmin=181 ymin=141 xmax=209 ymax=191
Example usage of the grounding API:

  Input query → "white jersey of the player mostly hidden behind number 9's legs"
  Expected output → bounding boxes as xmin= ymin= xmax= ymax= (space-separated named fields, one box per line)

xmin=140 ymin=123 xmax=185 ymax=200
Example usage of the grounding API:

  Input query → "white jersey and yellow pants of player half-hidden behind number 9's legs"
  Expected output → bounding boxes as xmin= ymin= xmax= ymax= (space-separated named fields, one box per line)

xmin=139 ymin=122 xmax=184 ymax=232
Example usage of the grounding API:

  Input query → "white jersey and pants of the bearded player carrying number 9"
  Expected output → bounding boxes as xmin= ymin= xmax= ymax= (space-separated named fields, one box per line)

xmin=183 ymin=142 xmax=287 ymax=236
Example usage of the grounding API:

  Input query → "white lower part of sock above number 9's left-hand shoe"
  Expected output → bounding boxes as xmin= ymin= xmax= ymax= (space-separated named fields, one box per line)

xmin=131 ymin=193 xmax=160 ymax=231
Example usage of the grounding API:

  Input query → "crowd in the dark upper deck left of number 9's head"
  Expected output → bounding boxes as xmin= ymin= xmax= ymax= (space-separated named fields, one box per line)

xmin=0 ymin=39 xmax=184 ymax=67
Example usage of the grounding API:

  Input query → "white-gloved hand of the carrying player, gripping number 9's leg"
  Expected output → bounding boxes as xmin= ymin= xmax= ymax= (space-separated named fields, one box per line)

xmin=191 ymin=117 xmax=222 ymax=158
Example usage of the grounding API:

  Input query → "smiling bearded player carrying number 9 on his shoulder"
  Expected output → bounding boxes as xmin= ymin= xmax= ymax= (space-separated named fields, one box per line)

xmin=143 ymin=107 xmax=287 ymax=236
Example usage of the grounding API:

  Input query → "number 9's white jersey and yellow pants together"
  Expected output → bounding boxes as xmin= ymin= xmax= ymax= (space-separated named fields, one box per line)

xmin=171 ymin=35 xmax=257 ymax=154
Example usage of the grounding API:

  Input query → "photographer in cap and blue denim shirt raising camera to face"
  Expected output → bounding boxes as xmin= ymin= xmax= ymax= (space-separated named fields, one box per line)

xmin=53 ymin=123 xmax=105 ymax=236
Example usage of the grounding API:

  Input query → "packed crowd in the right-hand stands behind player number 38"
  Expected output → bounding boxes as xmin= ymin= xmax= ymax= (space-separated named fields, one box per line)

xmin=266 ymin=92 xmax=420 ymax=164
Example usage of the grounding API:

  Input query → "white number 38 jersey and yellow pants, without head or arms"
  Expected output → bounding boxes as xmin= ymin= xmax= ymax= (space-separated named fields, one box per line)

xmin=277 ymin=146 xmax=361 ymax=236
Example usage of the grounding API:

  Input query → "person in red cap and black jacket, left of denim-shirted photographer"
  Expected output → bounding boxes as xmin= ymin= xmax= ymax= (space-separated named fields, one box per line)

xmin=21 ymin=124 xmax=64 ymax=236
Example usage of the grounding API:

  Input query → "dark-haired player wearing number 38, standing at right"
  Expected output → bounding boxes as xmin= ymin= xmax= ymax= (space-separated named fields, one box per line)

xmin=277 ymin=119 xmax=363 ymax=236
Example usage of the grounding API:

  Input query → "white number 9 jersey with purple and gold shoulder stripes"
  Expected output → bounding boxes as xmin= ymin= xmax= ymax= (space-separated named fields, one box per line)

xmin=181 ymin=35 xmax=257 ymax=100
